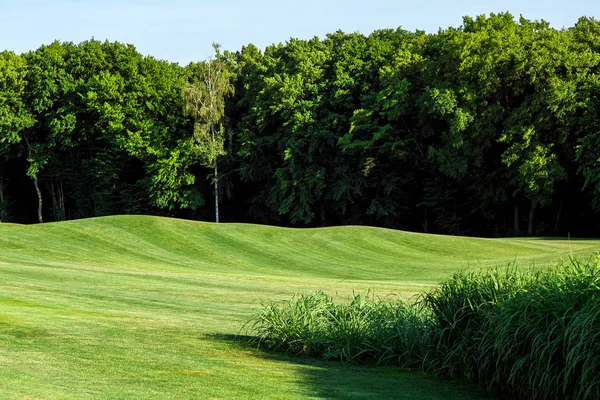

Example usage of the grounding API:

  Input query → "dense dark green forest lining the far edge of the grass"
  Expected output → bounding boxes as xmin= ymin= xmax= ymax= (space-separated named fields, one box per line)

xmin=0 ymin=13 xmax=600 ymax=236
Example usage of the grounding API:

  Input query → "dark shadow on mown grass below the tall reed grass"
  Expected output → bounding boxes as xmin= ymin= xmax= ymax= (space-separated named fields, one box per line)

xmin=209 ymin=334 xmax=508 ymax=400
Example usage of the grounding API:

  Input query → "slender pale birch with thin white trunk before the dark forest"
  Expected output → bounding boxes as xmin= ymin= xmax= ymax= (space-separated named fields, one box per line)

xmin=183 ymin=43 xmax=234 ymax=223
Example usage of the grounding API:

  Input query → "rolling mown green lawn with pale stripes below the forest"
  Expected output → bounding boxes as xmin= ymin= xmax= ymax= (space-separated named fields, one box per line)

xmin=0 ymin=216 xmax=600 ymax=399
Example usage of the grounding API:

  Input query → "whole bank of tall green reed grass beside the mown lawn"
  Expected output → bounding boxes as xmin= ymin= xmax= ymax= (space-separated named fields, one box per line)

xmin=249 ymin=258 xmax=600 ymax=399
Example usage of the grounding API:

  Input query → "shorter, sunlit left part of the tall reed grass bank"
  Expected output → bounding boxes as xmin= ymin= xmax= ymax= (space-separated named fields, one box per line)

xmin=246 ymin=292 xmax=428 ymax=365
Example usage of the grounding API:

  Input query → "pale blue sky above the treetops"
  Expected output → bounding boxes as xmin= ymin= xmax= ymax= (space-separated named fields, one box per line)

xmin=0 ymin=0 xmax=600 ymax=65
